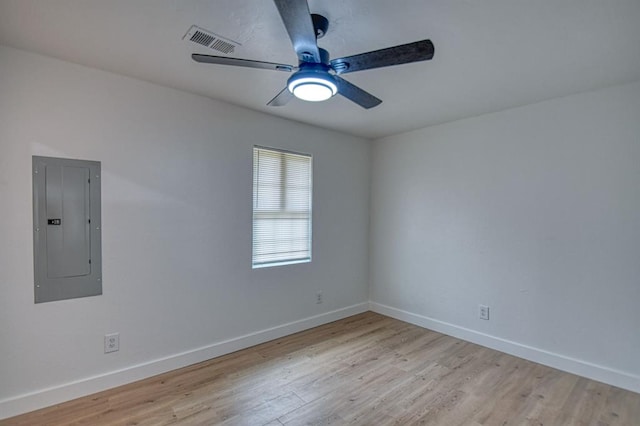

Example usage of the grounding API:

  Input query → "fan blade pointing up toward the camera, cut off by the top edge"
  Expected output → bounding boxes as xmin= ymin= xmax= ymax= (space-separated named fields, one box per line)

xmin=273 ymin=0 xmax=320 ymax=62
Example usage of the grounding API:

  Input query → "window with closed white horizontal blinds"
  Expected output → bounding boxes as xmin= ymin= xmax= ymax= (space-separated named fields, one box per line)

xmin=252 ymin=147 xmax=312 ymax=268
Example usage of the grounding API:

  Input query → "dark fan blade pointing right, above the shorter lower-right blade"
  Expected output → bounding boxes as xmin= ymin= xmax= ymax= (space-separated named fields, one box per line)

xmin=331 ymin=40 xmax=433 ymax=74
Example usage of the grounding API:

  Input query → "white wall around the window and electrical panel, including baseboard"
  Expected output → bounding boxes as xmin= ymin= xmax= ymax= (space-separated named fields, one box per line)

xmin=0 ymin=47 xmax=370 ymax=418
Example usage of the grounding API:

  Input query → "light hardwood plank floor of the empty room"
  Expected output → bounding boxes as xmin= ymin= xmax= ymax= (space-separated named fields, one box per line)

xmin=0 ymin=312 xmax=640 ymax=426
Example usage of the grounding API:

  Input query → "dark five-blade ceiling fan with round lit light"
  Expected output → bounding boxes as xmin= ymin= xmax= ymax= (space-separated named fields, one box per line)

xmin=191 ymin=0 xmax=434 ymax=109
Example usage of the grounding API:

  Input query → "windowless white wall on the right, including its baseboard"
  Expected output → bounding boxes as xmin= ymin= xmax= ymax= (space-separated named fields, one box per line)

xmin=370 ymin=83 xmax=640 ymax=392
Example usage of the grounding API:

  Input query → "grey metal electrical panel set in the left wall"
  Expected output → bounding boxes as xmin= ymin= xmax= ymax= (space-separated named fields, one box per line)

xmin=33 ymin=156 xmax=102 ymax=303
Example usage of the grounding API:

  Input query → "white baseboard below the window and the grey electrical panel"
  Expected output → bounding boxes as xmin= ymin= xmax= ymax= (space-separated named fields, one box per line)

xmin=0 ymin=303 xmax=369 ymax=420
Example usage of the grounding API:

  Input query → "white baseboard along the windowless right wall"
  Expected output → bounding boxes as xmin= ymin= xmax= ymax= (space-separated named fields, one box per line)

xmin=369 ymin=302 xmax=640 ymax=393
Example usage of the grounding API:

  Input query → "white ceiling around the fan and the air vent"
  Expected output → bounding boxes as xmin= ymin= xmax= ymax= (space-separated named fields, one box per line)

xmin=0 ymin=0 xmax=640 ymax=138
